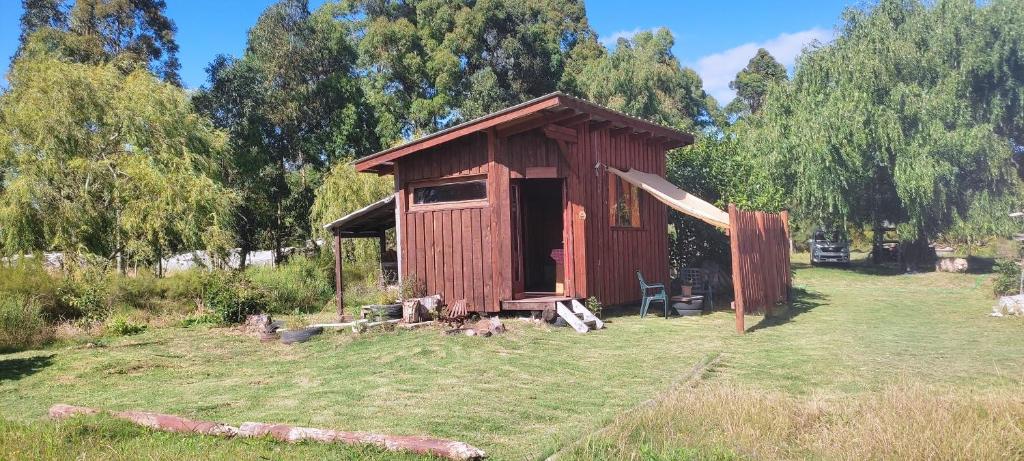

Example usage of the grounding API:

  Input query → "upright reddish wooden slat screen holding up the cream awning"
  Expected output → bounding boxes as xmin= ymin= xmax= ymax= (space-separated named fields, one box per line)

xmin=729 ymin=204 xmax=793 ymax=333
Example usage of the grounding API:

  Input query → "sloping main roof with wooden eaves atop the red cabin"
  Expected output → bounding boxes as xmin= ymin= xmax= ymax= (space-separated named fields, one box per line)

xmin=355 ymin=92 xmax=693 ymax=174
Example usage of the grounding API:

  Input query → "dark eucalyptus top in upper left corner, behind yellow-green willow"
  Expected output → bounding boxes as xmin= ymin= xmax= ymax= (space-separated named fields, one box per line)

xmin=16 ymin=0 xmax=181 ymax=86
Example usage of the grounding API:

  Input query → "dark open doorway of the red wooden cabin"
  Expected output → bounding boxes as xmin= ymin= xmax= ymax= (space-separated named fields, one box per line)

xmin=519 ymin=179 xmax=562 ymax=293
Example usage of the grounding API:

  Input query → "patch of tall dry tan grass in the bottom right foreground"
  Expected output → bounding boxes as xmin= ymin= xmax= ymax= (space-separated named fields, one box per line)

xmin=566 ymin=383 xmax=1024 ymax=460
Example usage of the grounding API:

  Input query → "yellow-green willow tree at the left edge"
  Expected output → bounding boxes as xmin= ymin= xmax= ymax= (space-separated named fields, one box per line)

xmin=0 ymin=56 xmax=233 ymax=270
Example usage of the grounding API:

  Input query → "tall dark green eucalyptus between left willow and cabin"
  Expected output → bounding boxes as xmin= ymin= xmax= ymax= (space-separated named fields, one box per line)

xmin=196 ymin=0 xmax=380 ymax=259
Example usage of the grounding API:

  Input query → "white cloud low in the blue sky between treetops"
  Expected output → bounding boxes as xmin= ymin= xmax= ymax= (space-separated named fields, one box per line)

xmin=693 ymin=28 xmax=834 ymax=106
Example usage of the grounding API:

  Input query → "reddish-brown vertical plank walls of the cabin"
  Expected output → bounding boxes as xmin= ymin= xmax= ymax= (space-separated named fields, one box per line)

xmin=394 ymin=126 xmax=669 ymax=312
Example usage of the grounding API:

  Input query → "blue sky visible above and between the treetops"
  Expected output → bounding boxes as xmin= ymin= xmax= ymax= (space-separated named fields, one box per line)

xmin=0 ymin=0 xmax=855 ymax=104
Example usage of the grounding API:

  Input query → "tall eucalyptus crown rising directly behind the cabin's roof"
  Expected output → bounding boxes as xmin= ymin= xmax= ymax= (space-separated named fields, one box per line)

xmin=349 ymin=0 xmax=599 ymax=141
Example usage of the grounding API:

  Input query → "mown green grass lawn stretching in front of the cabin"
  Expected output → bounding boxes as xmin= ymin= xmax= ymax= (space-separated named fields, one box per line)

xmin=0 ymin=257 xmax=1024 ymax=459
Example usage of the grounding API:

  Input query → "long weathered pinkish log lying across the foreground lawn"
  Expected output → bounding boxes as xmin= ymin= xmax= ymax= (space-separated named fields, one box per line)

xmin=49 ymin=404 xmax=487 ymax=460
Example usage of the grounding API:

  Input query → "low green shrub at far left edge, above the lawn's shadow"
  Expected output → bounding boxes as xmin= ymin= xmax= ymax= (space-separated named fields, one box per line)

xmin=0 ymin=294 xmax=53 ymax=350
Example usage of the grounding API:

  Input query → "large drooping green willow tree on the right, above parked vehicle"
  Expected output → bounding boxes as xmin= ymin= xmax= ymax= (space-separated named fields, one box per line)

xmin=743 ymin=0 xmax=1012 ymax=262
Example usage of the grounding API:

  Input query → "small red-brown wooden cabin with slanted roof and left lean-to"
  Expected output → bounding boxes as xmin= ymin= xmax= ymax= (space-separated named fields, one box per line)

xmin=326 ymin=93 xmax=693 ymax=312
